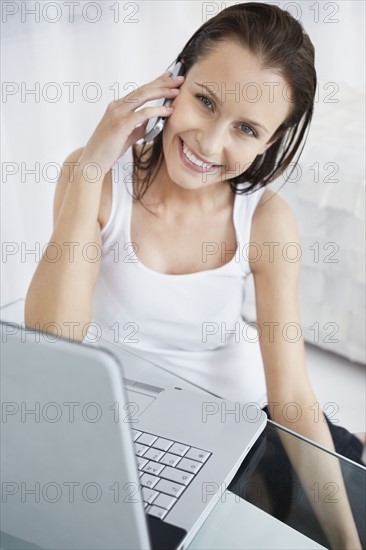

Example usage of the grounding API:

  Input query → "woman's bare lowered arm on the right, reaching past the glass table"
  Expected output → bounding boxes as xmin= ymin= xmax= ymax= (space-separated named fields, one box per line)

xmin=250 ymin=190 xmax=361 ymax=549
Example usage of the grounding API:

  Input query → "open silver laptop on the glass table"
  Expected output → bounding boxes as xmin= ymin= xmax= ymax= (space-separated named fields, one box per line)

xmin=0 ymin=321 xmax=267 ymax=550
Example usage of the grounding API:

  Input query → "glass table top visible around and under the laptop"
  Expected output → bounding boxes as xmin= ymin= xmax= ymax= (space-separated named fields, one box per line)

xmin=0 ymin=299 xmax=366 ymax=550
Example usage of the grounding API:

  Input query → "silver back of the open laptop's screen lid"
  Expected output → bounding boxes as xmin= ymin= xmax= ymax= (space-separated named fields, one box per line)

xmin=0 ymin=321 xmax=186 ymax=549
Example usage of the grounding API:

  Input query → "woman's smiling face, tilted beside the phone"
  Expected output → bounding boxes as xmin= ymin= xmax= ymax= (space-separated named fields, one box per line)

xmin=163 ymin=41 xmax=292 ymax=190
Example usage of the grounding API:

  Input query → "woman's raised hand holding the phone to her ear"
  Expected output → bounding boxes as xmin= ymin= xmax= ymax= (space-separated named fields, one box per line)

xmin=79 ymin=72 xmax=184 ymax=174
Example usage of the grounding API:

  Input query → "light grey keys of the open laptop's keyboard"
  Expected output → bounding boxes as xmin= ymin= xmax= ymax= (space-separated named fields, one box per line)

xmin=132 ymin=430 xmax=211 ymax=519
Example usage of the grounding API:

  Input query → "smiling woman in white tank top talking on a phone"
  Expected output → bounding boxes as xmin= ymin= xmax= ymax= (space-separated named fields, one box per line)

xmin=25 ymin=3 xmax=362 ymax=548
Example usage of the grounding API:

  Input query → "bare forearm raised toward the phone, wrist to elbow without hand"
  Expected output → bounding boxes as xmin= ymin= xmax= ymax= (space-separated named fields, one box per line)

xmin=25 ymin=148 xmax=106 ymax=341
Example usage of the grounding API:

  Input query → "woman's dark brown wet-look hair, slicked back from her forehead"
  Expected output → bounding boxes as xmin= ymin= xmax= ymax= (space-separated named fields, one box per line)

xmin=132 ymin=2 xmax=317 ymax=200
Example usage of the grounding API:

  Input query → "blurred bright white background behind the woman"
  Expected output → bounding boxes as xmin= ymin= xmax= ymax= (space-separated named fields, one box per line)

xmin=0 ymin=0 xmax=366 ymax=431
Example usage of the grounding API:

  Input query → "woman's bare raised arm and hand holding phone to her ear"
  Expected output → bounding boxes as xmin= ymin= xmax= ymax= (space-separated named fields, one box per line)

xmin=25 ymin=73 xmax=183 ymax=340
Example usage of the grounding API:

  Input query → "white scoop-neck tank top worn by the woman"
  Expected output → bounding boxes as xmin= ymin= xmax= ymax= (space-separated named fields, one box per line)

xmin=91 ymin=147 xmax=266 ymax=401
